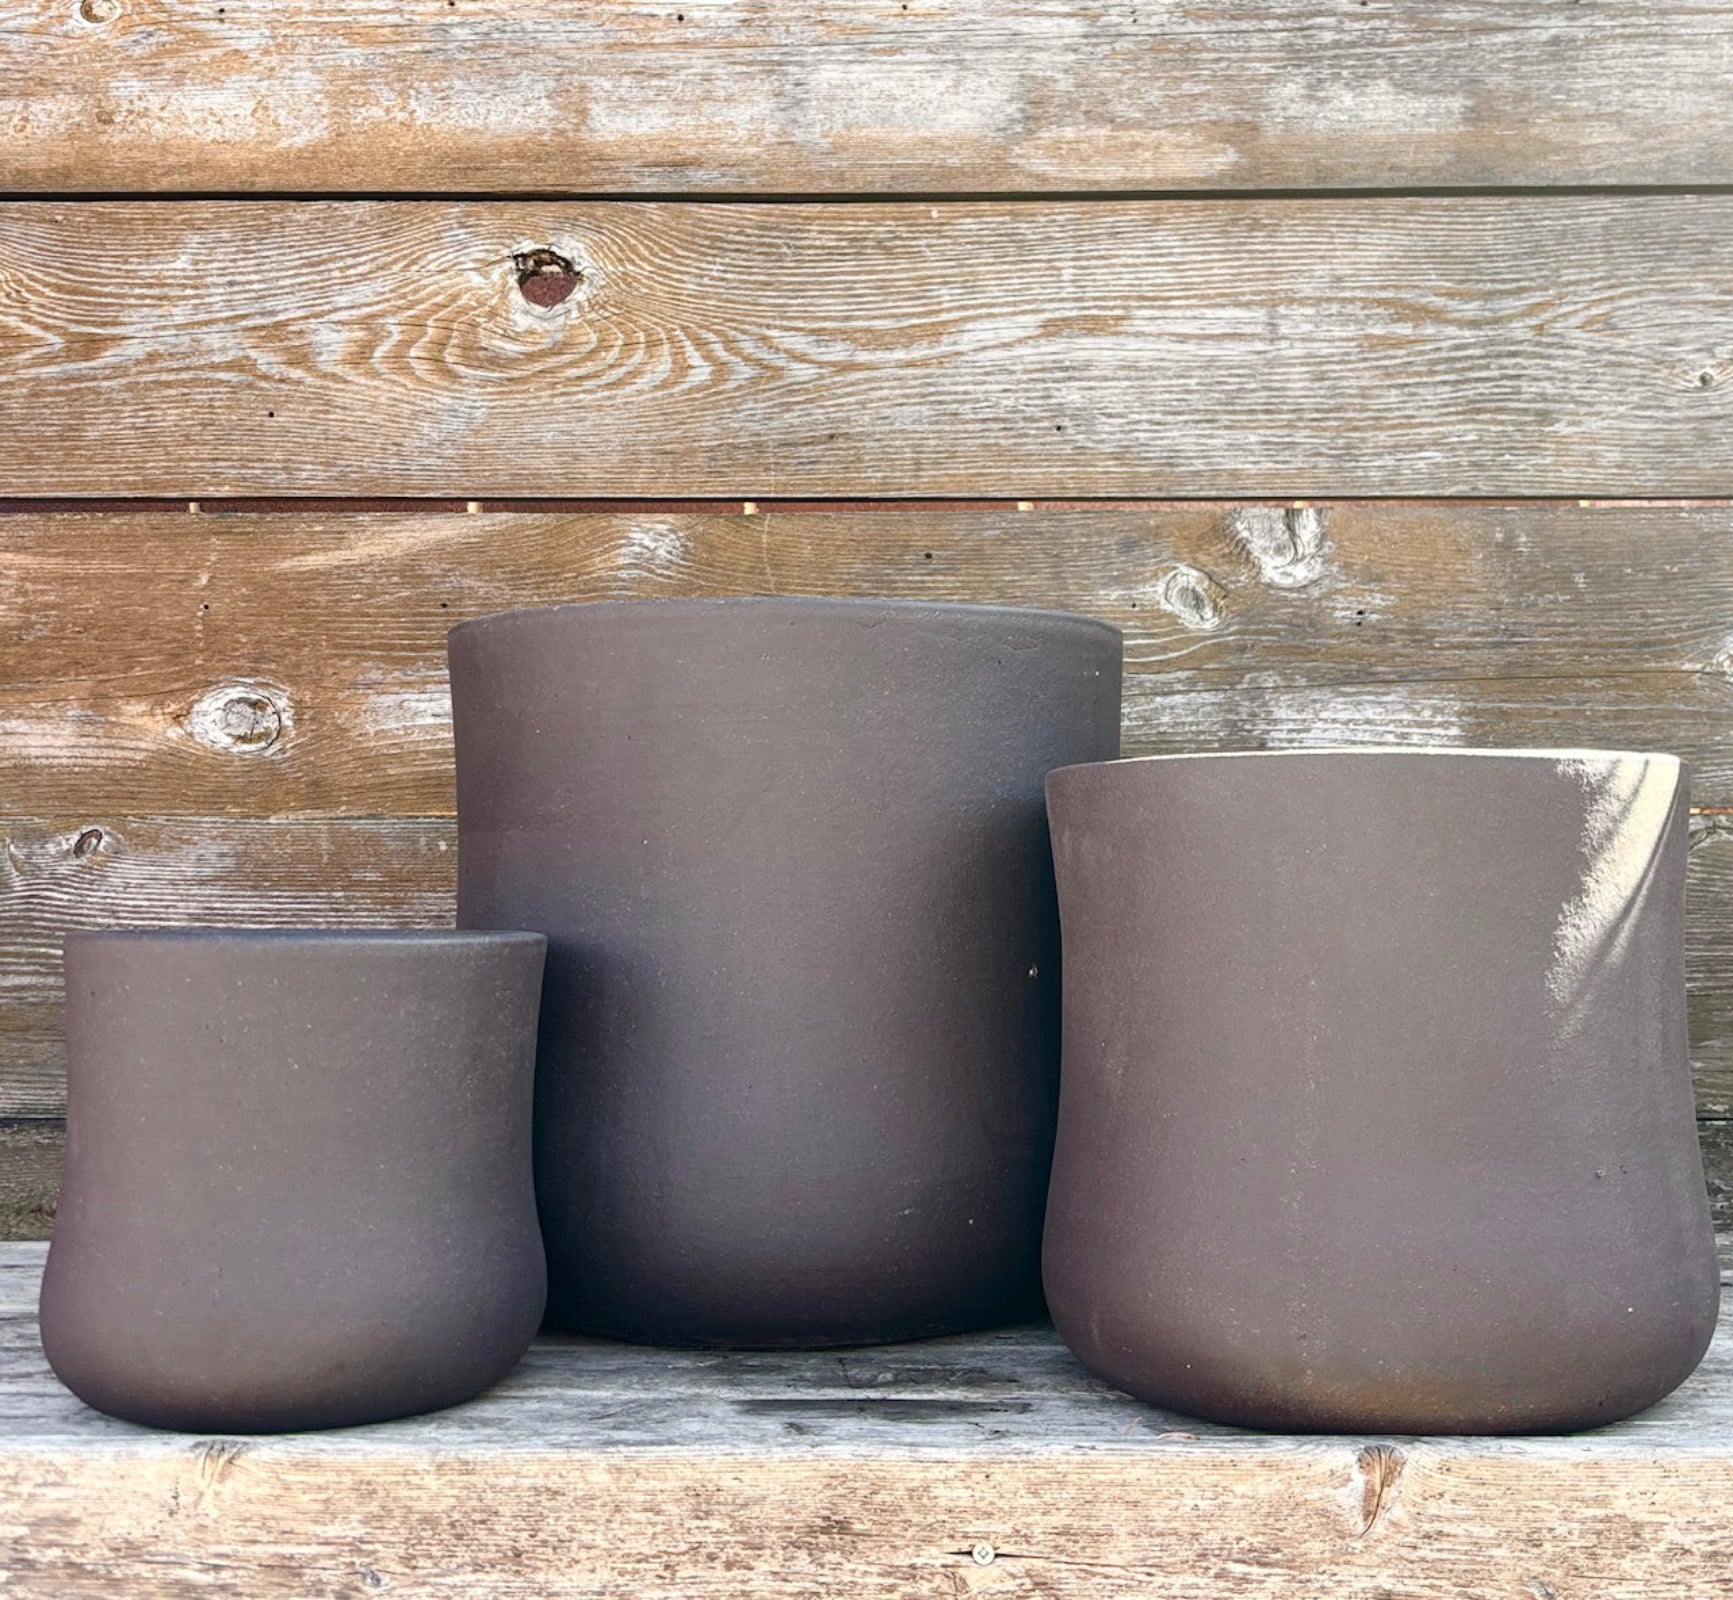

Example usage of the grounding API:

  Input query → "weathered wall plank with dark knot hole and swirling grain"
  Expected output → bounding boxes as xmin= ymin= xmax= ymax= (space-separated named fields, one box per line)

xmin=0 ymin=203 xmax=1733 ymax=498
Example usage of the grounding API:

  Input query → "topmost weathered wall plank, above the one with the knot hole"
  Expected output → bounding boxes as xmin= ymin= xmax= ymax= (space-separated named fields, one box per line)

xmin=0 ymin=0 xmax=1733 ymax=194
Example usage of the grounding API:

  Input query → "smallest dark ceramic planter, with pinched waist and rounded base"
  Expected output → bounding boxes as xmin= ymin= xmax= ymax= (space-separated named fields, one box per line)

xmin=42 ymin=929 xmax=546 ymax=1432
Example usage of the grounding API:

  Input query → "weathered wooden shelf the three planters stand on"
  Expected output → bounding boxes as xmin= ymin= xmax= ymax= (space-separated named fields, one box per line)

xmin=0 ymin=1245 xmax=1733 ymax=1600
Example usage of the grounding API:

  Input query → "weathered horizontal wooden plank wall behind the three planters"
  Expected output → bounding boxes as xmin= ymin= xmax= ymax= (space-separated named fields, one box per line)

xmin=0 ymin=0 xmax=1733 ymax=1238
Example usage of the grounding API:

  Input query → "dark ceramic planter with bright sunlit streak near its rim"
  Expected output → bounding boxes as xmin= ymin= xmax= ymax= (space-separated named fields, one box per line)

xmin=1045 ymin=751 xmax=1717 ymax=1434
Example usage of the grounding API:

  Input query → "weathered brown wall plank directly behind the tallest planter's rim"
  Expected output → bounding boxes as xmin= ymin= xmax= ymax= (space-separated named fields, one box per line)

xmin=0 ymin=504 xmax=1733 ymax=820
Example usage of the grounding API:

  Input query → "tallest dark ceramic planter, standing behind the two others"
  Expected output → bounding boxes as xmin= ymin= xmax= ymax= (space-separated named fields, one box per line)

xmin=451 ymin=600 xmax=1120 ymax=1345
